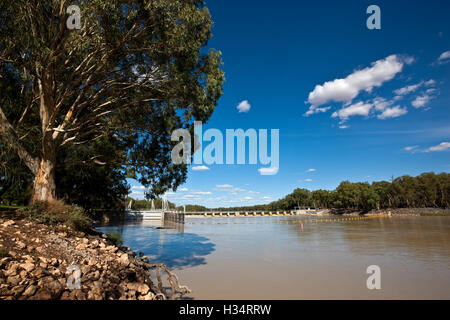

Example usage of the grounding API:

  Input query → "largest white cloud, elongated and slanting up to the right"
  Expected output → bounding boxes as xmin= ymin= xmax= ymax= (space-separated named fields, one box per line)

xmin=307 ymin=55 xmax=410 ymax=114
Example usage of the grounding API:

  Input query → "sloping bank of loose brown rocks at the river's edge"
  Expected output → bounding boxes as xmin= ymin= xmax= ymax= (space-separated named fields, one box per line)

xmin=0 ymin=218 xmax=189 ymax=300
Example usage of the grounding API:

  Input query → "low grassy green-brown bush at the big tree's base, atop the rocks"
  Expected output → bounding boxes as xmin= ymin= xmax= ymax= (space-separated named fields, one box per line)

xmin=18 ymin=201 xmax=92 ymax=231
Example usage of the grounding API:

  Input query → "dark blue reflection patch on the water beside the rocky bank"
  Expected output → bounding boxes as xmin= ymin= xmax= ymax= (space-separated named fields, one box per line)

xmin=98 ymin=220 xmax=215 ymax=269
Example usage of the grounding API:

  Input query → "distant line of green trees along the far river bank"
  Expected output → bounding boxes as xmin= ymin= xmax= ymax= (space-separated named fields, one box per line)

xmin=185 ymin=172 xmax=450 ymax=211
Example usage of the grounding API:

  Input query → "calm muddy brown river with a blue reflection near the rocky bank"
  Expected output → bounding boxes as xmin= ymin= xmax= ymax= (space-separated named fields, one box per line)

xmin=99 ymin=216 xmax=450 ymax=299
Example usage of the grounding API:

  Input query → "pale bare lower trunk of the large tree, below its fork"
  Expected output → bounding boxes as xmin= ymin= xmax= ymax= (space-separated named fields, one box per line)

xmin=31 ymin=159 xmax=56 ymax=203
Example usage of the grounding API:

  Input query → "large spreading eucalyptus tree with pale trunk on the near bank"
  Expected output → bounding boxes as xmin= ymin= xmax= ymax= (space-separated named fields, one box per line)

xmin=0 ymin=0 xmax=224 ymax=201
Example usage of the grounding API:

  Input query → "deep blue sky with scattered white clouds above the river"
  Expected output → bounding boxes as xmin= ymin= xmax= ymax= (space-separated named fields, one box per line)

xmin=129 ymin=0 xmax=450 ymax=207
